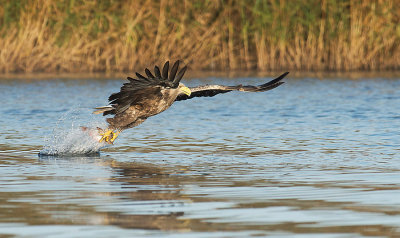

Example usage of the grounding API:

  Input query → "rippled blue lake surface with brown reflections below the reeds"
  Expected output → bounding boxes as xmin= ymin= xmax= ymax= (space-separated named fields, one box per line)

xmin=0 ymin=74 xmax=400 ymax=237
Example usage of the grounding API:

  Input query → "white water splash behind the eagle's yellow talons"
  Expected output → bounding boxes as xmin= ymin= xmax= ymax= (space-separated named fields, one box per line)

xmin=39 ymin=109 xmax=108 ymax=156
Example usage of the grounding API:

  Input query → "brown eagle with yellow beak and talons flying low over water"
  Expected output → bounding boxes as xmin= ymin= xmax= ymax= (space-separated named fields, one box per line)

xmin=93 ymin=60 xmax=289 ymax=144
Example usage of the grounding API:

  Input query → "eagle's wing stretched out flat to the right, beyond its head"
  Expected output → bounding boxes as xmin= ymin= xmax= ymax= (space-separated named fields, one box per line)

xmin=175 ymin=72 xmax=289 ymax=101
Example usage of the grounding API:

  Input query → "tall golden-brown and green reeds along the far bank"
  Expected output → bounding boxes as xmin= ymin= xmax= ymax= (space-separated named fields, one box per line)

xmin=0 ymin=0 xmax=400 ymax=73
